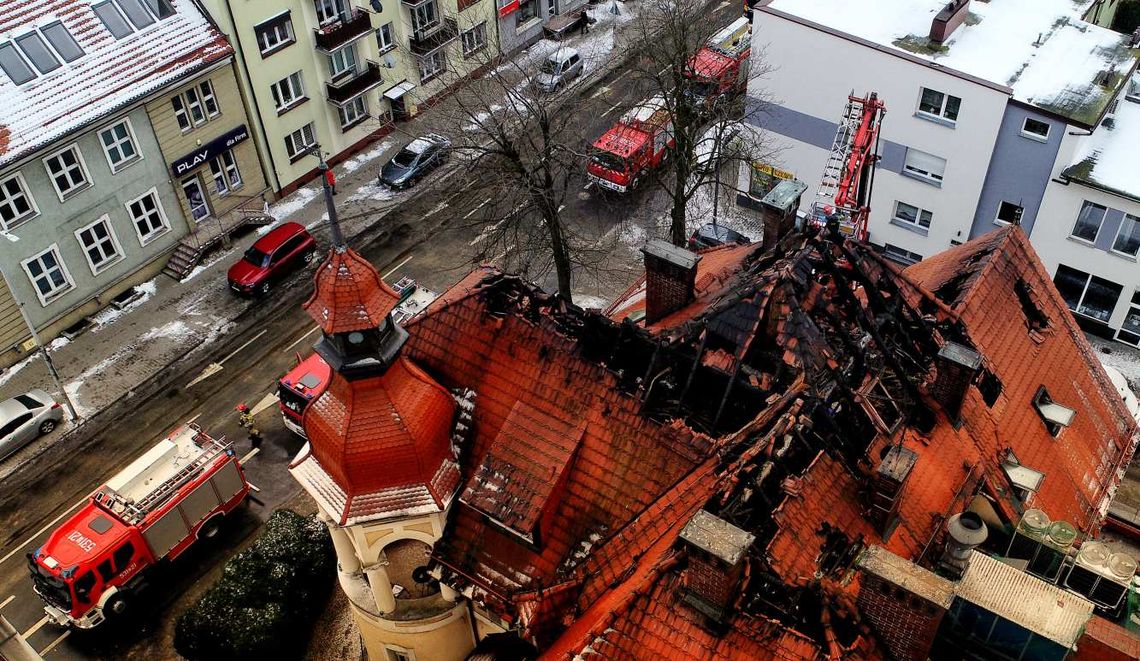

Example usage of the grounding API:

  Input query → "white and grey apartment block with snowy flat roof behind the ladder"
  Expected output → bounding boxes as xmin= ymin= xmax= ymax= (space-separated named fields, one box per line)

xmin=740 ymin=0 xmax=1135 ymax=262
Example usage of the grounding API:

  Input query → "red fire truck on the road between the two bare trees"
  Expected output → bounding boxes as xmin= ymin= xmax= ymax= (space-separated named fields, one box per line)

xmin=586 ymin=97 xmax=674 ymax=193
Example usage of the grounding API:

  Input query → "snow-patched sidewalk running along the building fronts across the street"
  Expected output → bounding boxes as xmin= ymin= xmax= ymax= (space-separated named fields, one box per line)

xmin=0 ymin=2 xmax=647 ymax=464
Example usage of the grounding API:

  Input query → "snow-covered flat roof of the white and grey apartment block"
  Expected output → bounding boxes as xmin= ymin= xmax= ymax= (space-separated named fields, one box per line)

xmin=771 ymin=0 xmax=1135 ymax=125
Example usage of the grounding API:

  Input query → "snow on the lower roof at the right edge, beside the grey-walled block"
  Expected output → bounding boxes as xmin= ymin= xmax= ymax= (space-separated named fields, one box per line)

xmin=1065 ymin=100 xmax=1140 ymax=199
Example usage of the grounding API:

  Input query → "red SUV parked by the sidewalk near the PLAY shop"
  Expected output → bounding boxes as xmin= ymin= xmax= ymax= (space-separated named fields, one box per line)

xmin=227 ymin=222 xmax=317 ymax=296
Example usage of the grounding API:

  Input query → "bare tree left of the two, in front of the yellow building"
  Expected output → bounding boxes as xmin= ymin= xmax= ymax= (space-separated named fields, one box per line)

xmin=419 ymin=37 xmax=593 ymax=300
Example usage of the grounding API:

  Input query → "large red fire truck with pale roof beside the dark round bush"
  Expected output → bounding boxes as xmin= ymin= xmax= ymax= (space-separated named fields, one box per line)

xmin=27 ymin=424 xmax=251 ymax=629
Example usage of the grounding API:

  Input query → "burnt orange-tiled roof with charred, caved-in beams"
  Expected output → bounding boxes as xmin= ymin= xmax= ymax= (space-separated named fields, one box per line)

xmin=389 ymin=223 xmax=1135 ymax=658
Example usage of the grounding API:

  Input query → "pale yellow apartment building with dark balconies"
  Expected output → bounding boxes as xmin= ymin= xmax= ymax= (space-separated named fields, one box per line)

xmin=203 ymin=0 xmax=498 ymax=195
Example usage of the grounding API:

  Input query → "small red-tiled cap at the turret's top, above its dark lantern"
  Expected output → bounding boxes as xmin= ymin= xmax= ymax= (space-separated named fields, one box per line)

xmin=304 ymin=248 xmax=400 ymax=335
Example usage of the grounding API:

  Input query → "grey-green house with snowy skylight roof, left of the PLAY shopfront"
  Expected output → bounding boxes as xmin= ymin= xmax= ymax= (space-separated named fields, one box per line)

xmin=0 ymin=0 xmax=233 ymax=365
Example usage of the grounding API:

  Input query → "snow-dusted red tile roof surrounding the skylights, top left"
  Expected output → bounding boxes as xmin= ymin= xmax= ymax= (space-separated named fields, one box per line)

xmin=0 ymin=0 xmax=233 ymax=166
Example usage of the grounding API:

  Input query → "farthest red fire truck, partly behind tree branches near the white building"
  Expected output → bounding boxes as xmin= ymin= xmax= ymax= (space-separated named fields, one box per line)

xmin=685 ymin=18 xmax=752 ymax=109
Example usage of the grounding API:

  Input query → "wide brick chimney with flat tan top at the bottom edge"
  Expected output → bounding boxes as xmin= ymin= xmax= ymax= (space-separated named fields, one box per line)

xmin=855 ymin=546 xmax=954 ymax=661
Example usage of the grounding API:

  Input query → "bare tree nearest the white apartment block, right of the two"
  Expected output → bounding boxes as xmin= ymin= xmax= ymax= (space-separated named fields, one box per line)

xmin=627 ymin=0 xmax=775 ymax=245
